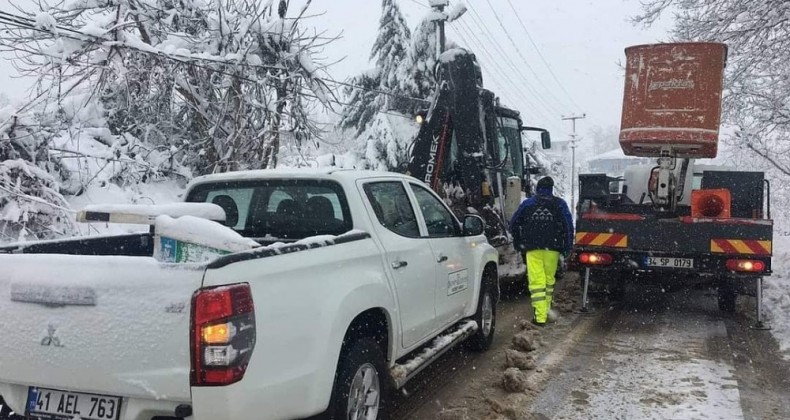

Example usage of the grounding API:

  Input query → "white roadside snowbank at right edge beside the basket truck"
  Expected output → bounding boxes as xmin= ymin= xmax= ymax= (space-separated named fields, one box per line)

xmin=763 ymin=235 xmax=790 ymax=359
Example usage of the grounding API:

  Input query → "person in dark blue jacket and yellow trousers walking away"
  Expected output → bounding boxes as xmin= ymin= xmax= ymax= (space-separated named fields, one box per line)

xmin=510 ymin=176 xmax=573 ymax=326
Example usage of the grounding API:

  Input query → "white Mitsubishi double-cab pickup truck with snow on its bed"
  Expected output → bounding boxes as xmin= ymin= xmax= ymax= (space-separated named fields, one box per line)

xmin=0 ymin=170 xmax=499 ymax=420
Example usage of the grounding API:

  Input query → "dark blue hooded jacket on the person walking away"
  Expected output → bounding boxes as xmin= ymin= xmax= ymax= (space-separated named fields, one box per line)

xmin=510 ymin=188 xmax=573 ymax=255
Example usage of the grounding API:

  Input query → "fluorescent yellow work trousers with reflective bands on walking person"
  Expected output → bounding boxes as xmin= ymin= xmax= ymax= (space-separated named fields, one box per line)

xmin=527 ymin=249 xmax=560 ymax=324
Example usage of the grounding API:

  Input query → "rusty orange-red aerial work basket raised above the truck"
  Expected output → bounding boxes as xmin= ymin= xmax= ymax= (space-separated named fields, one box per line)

xmin=620 ymin=42 xmax=727 ymax=158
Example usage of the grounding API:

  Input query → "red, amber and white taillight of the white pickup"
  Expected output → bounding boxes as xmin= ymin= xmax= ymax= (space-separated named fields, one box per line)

xmin=191 ymin=283 xmax=255 ymax=386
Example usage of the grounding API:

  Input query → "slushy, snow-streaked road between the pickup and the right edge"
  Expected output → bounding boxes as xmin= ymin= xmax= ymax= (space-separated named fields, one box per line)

xmin=403 ymin=278 xmax=790 ymax=420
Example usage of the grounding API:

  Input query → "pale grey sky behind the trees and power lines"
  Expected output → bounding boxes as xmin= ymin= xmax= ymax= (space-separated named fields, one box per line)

xmin=0 ymin=0 xmax=666 ymax=140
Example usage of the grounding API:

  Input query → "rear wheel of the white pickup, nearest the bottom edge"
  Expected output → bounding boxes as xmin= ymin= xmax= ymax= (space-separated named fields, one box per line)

xmin=331 ymin=337 xmax=390 ymax=420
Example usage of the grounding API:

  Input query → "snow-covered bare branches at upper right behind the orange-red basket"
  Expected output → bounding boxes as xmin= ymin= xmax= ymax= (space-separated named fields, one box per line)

xmin=634 ymin=0 xmax=790 ymax=176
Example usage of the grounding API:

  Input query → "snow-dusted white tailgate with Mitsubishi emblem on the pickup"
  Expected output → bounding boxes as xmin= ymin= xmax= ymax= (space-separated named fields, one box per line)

xmin=0 ymin=255 xmax=204 ymax=410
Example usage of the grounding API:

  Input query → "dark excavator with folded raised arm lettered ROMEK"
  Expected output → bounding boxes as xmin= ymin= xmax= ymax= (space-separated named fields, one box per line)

xmin=406 ymin=48 xmax=551 ymax=275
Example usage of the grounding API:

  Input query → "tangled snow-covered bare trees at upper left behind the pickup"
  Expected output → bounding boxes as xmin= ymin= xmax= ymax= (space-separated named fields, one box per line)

xmin=0 ymin=0 xmax=332 ymax=240
